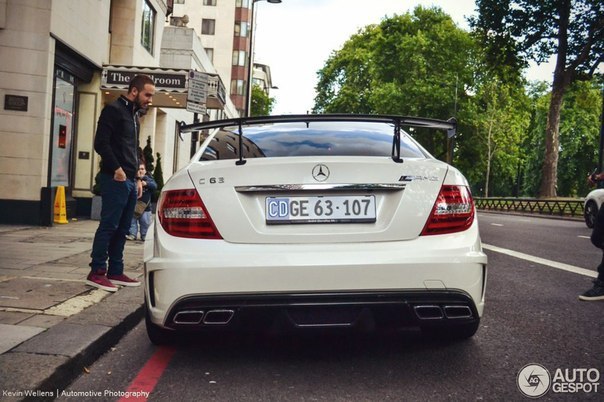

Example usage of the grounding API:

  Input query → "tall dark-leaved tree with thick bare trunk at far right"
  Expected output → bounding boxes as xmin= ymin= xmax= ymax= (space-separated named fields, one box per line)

xmin=470 ymin=0 xmax=604 ymax=197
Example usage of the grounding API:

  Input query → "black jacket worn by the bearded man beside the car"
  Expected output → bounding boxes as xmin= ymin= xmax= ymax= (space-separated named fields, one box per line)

xmin=94 ymin=96 xmax=139 ymax=179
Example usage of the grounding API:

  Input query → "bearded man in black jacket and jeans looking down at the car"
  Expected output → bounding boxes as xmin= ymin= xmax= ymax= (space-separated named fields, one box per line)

xmin=86 ymin=75 xmax=155 ymax=292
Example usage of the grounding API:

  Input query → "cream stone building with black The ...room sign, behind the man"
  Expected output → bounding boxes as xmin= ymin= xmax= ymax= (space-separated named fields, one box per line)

xmin=0 ymin=0 xmax=237 ymax=225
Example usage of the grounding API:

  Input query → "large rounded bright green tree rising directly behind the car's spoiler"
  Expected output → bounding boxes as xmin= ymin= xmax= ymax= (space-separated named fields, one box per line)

xmin=313 ymin=7 xmax=475 ymax=157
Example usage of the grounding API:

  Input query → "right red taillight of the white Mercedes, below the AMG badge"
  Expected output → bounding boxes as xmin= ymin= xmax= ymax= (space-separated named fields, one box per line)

xmin=422 ymin=185 xmax=474 ymax=236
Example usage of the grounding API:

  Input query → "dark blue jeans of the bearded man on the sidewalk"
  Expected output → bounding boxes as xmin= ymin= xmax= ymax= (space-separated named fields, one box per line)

xmin=90 ymin=173 xmax=138 ymax=275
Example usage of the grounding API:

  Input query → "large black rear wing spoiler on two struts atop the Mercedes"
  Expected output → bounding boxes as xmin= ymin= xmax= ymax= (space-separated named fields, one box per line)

xmin=179 ymin=113 xmax=457 ymax=165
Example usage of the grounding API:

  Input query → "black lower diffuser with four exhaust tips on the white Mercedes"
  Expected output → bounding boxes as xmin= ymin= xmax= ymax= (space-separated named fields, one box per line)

xmin=152 ymin=291 xmax=480 ymax=331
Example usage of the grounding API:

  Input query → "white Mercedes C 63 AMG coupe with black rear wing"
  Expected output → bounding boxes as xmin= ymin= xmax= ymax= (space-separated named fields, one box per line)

xmin=144 ymin=114 xmax=487 ymax=344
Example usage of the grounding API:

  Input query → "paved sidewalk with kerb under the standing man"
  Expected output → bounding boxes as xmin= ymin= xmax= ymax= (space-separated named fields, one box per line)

xmin=0 ymin=220 xmax=143 ymax=400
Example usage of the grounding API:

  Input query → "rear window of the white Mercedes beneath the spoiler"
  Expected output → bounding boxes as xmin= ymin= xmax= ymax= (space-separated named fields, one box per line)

xmin=200 ymin=122 xmax=428 ymax=160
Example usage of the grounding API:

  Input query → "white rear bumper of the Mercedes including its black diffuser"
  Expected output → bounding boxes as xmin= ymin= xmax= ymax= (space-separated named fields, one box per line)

xmin=145 ymin=223 xmax=487 ymax=329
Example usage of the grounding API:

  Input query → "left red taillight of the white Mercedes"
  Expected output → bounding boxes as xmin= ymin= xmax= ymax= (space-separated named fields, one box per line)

xmin=157 ymin=189 xmax=222 ymax=239
